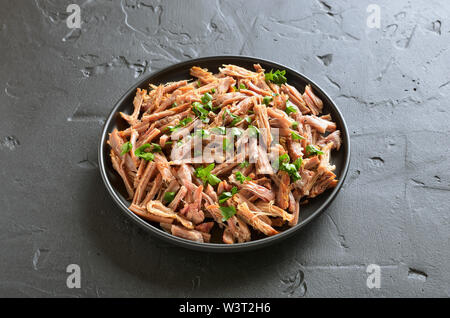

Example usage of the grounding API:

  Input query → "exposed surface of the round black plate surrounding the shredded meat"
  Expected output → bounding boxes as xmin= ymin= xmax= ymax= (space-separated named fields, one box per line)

xmin=98 ymin=56 xmax=350 ymax=252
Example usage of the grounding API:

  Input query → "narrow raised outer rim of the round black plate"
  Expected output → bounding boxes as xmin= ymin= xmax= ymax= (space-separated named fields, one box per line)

xmin=98 ymin=55 xmax=351 ymax=252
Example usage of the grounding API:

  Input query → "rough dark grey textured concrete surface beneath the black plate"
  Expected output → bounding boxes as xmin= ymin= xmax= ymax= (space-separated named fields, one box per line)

xmin=0 ymin=0 xmax=450 ymax=297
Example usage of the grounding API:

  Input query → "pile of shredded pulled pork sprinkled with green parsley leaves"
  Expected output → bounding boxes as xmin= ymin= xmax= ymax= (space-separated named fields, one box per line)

xmin=108 ymin=65 xmax=341 ymax=244
